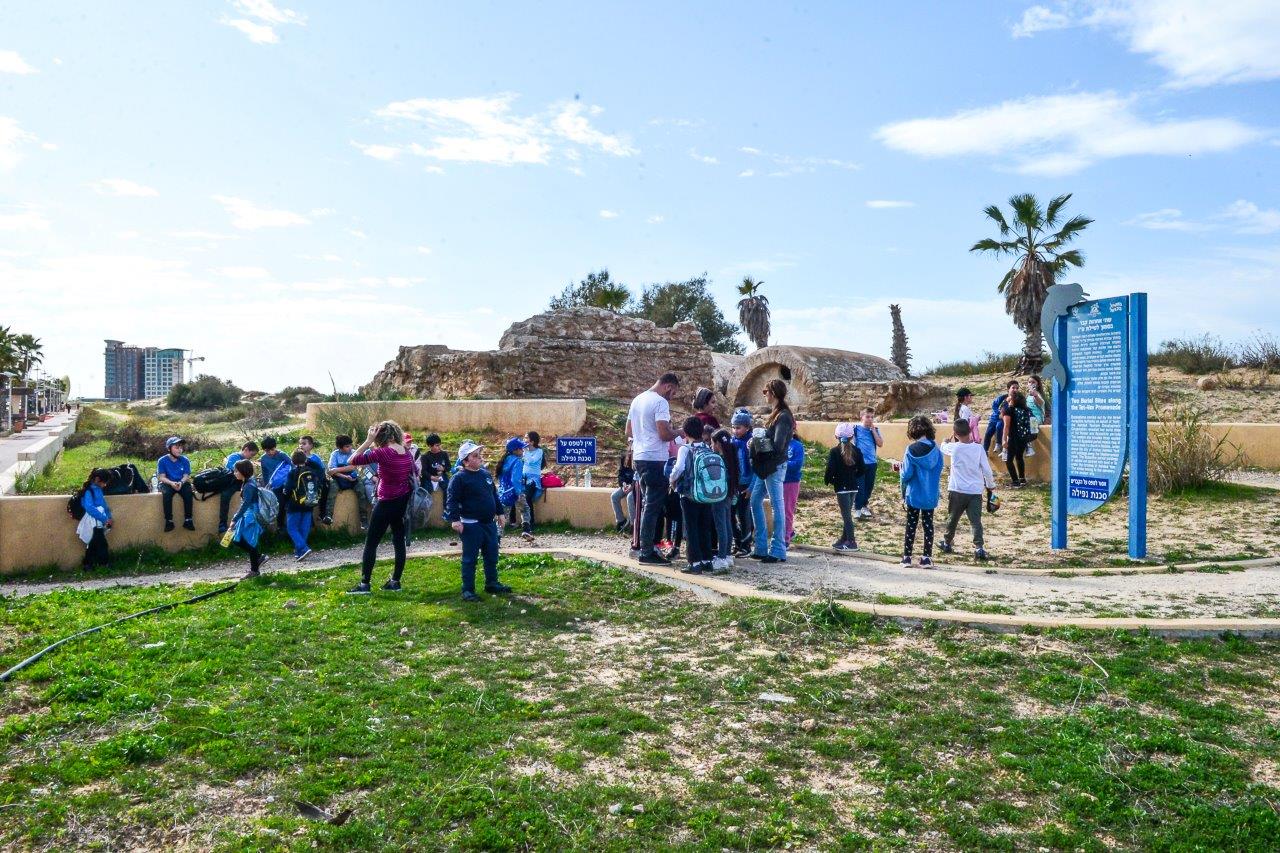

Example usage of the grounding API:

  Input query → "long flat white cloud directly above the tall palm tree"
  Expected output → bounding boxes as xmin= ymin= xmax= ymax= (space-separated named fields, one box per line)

xmin=876 ymin=92 xmax=1262 ymax=175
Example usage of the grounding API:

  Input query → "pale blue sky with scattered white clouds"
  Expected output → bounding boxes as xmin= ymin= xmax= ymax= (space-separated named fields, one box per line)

xmin=0 ymin=0 xmax=1280 ymax=394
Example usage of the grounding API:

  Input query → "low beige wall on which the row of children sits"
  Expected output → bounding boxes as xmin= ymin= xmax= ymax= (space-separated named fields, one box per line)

xmin=0 ymin=487 xmax=613 ymax=575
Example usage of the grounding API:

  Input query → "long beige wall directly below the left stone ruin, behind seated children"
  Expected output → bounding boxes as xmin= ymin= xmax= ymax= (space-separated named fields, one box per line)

xmin=307 ymin=400 xmax=586 ymax=442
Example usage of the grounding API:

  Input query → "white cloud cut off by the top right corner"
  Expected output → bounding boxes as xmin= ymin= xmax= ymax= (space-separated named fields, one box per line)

xmin=1014 ymin=0 xmax=1280 ymax=88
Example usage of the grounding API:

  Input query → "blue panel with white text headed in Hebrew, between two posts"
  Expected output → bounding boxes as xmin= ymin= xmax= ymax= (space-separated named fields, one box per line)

xmin=1065 ymin=296 xmax=1129 ymax=515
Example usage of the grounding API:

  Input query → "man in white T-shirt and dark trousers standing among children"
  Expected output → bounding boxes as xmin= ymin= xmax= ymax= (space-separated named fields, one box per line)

xmin=627 ymin=373 xmax=680 ymax=566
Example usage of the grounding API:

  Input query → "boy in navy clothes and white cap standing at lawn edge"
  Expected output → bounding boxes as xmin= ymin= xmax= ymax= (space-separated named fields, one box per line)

xmin=444 ymin=442 xmax=511 ymax=601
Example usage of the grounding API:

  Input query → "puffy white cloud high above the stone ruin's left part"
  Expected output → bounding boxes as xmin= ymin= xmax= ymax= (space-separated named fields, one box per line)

xmin=366 ymin=92 xmax=636 ymax=165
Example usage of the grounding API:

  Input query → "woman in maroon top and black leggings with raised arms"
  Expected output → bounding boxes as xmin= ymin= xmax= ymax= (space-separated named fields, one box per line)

xmin=347 ymin=420 xmax=416 ymax=596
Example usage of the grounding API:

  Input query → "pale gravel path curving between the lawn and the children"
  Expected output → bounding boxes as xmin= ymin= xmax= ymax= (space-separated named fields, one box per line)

xmin=0 ymin=534 xmax=1280 ymax=617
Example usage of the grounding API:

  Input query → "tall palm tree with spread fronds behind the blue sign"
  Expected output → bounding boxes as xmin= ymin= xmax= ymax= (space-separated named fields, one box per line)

xmin=969 ymin=192 xmax=1093 ymax=374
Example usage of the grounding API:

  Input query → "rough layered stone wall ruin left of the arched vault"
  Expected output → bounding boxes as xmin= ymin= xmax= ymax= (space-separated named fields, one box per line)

xmin=361 ymin=307 xmax=713 ymax=400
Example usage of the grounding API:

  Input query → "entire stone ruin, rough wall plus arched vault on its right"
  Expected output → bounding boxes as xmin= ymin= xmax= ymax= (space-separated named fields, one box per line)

xmin=361 ymin=307 xmax=947 ymax=420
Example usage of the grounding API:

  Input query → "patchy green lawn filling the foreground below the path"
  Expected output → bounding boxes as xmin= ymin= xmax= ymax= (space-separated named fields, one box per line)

xmin=0 ymin=556 xmax=1280 ymax=850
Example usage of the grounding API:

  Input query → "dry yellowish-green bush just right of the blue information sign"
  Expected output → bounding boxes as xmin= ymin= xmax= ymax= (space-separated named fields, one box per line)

xmin=1147 ymin=398 xmax=1242 ymax=494
